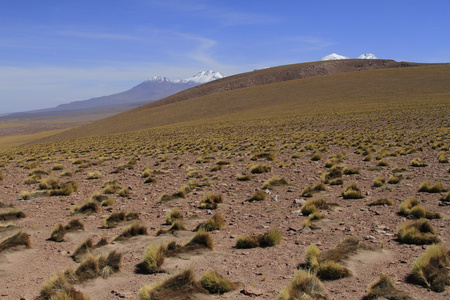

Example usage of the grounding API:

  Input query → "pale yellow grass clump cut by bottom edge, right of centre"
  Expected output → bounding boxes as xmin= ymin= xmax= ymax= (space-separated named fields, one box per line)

xmin=278 ymin=269 xmax=330 ymax=300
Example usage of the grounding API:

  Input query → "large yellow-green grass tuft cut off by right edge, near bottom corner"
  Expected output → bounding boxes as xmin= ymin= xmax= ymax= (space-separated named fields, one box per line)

xmin=409 ymin=244 xmax=450 ymax=293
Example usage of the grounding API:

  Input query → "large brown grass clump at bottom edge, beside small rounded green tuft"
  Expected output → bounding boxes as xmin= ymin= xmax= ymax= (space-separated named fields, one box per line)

xmin=139 ymin=267 xmax=208 ymax=300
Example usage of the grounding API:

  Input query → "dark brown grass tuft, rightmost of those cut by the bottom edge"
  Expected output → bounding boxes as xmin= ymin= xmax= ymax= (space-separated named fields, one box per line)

xmin=362 ymin=274 xmax=414 ymax=300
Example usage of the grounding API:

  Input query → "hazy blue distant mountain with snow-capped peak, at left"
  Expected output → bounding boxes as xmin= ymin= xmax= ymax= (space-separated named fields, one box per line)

xmin=1 ymin=70 xmax=224 ymax=118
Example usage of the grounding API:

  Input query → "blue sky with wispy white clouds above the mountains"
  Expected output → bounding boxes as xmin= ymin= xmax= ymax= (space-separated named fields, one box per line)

xmin=0 ymin=0 xmax=450 ymax=114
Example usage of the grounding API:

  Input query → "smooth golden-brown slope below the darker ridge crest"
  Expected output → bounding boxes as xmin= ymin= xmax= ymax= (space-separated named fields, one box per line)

xmin=39 ymin=65 xmax=450 ymax=141
